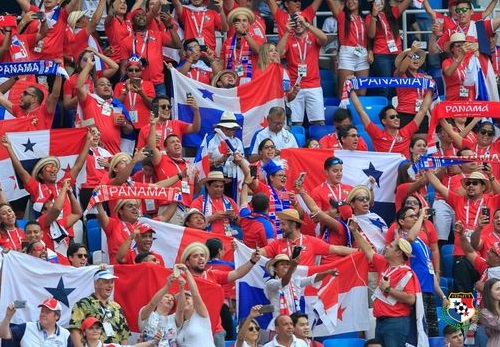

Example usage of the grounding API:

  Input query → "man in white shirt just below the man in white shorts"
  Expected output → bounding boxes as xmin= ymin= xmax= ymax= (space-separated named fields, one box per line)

xmin=249 ymin=106 xmax=299 ymax=163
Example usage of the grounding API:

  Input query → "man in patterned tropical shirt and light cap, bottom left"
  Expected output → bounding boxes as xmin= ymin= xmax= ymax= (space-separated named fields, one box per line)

xmin=69 ymin=270 xmax=130 ymax=347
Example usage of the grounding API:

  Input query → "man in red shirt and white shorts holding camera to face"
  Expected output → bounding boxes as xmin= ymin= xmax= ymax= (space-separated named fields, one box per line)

xmin=277 ymin=15 xmax=327 ymax=125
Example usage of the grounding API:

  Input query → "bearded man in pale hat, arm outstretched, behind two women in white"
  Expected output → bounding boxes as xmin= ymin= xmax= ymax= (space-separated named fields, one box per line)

xmin=180 ymin=242 xmax=260 ymax=347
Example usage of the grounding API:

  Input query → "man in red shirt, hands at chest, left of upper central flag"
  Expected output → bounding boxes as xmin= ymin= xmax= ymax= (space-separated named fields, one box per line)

xmin=114 ymin=55 xmax=155 ymax=132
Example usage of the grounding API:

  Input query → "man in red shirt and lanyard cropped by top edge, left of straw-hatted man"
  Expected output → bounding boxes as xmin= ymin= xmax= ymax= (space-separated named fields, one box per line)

xmin=172 ymin=0 xmax=228 ymax=52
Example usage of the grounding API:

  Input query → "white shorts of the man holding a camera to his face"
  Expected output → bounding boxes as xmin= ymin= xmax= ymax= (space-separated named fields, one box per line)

xmin=288 ymin=87 xmax=325 ymax=122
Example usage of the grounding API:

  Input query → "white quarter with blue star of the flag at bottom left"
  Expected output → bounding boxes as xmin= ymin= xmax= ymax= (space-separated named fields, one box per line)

xmin=0 ymin=252 xmax=98 ymax=326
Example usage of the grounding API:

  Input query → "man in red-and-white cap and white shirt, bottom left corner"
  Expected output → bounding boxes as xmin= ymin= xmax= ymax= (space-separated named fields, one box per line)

xmin=0 ymin=298 xmax=73 ymax=347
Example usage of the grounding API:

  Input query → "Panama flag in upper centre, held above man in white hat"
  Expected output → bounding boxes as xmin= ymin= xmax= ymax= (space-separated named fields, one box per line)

xmin=170 ymin=64 xmax=285 ymax=147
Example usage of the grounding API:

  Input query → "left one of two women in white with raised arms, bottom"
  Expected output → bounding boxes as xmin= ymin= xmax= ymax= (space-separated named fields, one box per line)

xmin=139 ymin=273 xmax=177 ymax=346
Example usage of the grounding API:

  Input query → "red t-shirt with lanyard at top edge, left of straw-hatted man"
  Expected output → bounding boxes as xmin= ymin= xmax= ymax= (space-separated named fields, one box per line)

xmin=179 ymin=6 xmax=222 ymax=51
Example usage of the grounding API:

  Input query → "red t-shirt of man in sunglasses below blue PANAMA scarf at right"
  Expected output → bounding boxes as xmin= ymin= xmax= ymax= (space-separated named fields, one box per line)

xmin=366 ymin=121 xmax=418 ymax=158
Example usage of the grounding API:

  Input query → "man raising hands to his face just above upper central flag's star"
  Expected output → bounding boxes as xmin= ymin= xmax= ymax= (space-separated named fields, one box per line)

xmin=177 ymin=38 xmax=222 ymax=84
